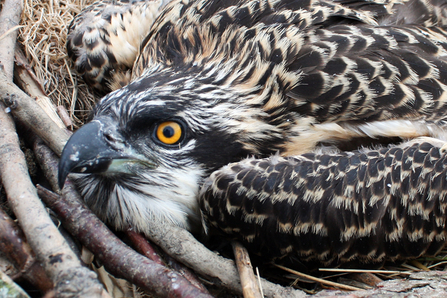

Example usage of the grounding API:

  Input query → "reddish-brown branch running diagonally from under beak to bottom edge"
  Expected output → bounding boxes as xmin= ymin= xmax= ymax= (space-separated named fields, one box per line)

xmin=38 ymin=181 xmax=211 ymax=297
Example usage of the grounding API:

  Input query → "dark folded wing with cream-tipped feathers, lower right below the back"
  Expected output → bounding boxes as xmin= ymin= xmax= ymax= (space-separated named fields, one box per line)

xmin=200 ymin=138 xmax=447 ymax=264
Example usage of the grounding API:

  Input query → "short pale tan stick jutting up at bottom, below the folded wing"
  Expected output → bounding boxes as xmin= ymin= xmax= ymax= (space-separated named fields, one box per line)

xmin=231 ymin=241 xmax=262 ymax=298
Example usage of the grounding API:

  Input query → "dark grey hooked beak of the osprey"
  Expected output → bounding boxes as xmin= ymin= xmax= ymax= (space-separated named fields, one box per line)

xmin=58 ymin=118 xmax=156 ymax=189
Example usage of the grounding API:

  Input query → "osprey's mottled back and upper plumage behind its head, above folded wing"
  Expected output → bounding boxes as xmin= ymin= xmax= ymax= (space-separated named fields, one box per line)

xmin=133 ymin=0 xmax=447 ymax=155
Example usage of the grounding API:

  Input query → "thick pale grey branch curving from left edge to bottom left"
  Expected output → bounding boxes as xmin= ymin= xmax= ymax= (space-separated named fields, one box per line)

xmin=0 ymin=92 xmax=110 ymax=297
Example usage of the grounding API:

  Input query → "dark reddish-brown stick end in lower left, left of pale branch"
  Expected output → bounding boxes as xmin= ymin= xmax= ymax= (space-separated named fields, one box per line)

xmin=0 ymin=209 xmax=53 ymax=292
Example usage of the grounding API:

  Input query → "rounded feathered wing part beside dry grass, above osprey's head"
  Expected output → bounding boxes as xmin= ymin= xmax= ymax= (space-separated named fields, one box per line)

xmin=67 ymin=0 xmax=169 ymax=91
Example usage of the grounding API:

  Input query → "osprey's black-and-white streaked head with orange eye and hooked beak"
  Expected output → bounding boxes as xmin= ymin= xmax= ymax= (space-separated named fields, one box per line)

xmin=58 ymin=62 xmax=288 ymax=232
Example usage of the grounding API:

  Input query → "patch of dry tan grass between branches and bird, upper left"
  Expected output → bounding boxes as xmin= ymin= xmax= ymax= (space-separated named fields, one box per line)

xmin=19 ymin=0 xmax=95 ymax=125
